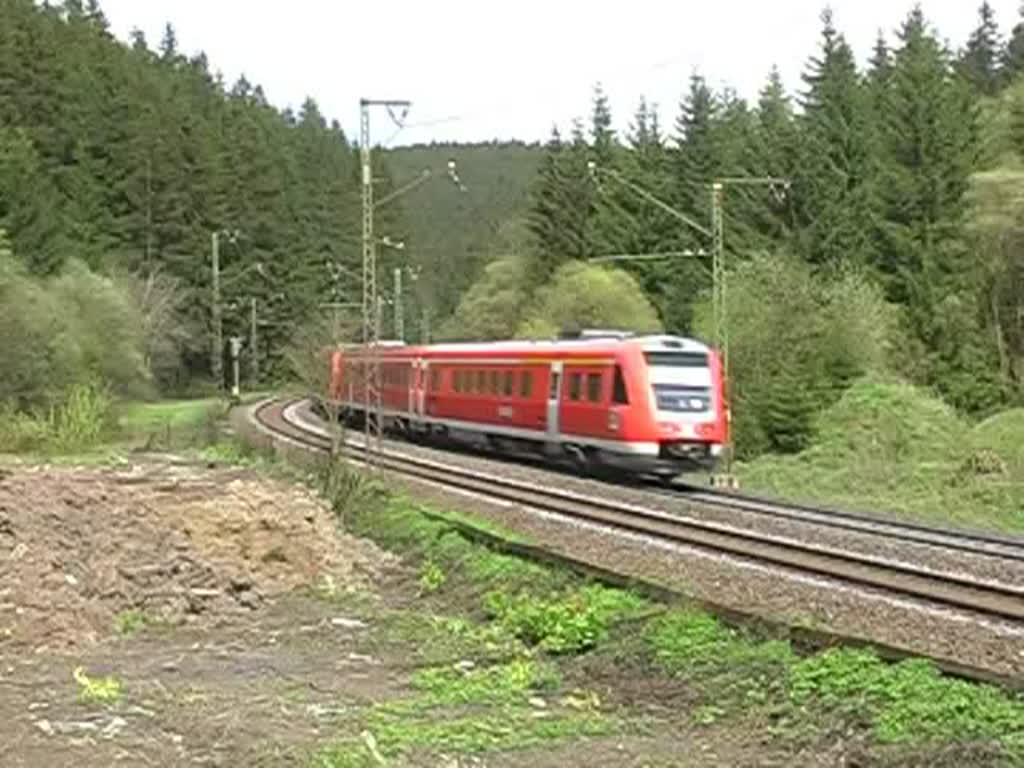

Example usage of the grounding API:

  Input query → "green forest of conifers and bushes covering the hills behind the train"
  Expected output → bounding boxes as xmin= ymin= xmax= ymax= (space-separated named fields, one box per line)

xmin=0 ymin=0 xmax=1024 ymax=466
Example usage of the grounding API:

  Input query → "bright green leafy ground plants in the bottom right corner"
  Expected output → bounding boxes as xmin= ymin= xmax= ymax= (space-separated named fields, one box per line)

xmin=646 ymin=611 xmax=1024 ymax=757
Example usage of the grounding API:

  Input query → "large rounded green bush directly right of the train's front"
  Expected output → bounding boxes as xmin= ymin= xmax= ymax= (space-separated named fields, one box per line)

xmin=696 ymin=254 xmax=898 ymax=458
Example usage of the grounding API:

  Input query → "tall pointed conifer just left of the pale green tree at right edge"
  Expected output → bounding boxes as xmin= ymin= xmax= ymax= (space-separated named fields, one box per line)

xmin=878 ymin=8 xmax=989 ymax=408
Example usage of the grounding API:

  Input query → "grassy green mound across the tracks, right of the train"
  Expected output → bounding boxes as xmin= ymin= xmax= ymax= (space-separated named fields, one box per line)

xmin=736 ymin=380 xmax=1024 ymax=532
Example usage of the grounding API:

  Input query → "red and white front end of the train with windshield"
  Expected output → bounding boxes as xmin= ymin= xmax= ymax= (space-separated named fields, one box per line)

xmin=618 ymin=336 xmax=728 ymax=476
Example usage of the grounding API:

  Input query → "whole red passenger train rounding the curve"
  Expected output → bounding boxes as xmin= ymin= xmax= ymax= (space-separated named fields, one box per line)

xmin=329 ymin=332 xmax=729 ymax=477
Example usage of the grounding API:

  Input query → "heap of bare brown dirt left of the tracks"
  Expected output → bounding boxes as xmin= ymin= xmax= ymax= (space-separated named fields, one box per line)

xmin=0 ymin=463 xmax=392 ymax=655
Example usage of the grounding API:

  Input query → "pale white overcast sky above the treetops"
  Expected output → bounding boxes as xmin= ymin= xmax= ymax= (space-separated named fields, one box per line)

xmin=101 ymin=0 xmax=1018 ymax=145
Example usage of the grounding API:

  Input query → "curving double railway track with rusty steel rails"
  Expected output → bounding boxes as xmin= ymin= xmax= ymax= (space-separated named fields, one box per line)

xmin=255 ymin=400 xmax=1024 ymax=622
